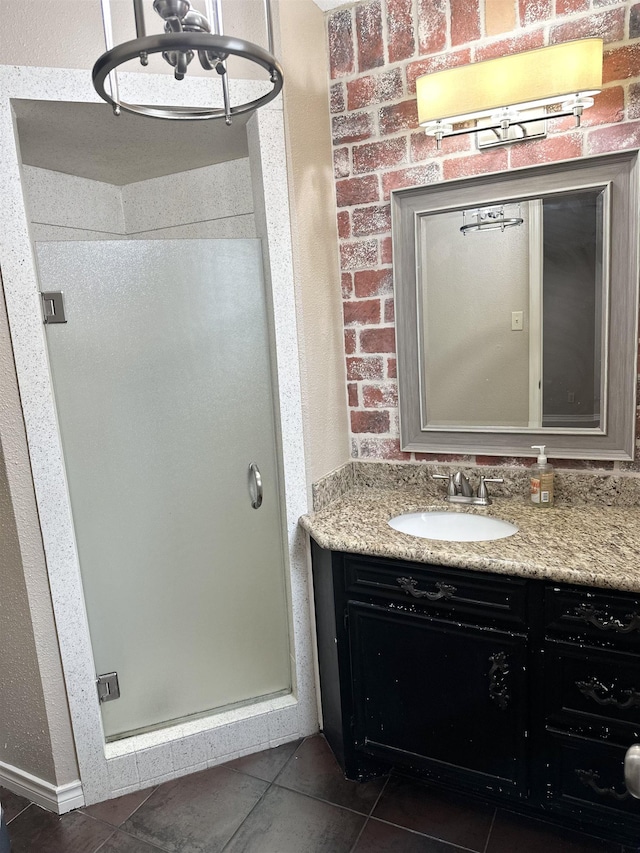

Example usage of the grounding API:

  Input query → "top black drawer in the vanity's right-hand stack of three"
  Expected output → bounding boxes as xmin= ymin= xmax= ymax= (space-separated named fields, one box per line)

xmin=545 ymin=585 xmax=640 ymax=649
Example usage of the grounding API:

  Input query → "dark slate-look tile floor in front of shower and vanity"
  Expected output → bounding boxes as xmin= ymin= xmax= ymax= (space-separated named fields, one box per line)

xmin=0 ymin=735 xmax=626 ymax=853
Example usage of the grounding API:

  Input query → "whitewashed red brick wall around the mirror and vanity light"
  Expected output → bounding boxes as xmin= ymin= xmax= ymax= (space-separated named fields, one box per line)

xmin=327 ymin=0 xmax=640 ymax=467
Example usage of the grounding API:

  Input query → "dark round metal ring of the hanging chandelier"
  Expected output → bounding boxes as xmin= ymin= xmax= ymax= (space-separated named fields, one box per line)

xmin=91 ymin=32 xmax=283 ymax=121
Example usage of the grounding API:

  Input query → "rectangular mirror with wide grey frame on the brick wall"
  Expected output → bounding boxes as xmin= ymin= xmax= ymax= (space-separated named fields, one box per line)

xmin=391 ymin=151 xmax=639 ymax=460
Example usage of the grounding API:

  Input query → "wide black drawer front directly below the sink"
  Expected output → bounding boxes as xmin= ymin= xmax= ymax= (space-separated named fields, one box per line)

xmin=344 ymin=554 xmax=527 ymax=624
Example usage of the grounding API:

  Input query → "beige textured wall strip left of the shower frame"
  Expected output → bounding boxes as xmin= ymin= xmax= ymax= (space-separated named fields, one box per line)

xmin=0 ymin=282 xmax=78 ymax=785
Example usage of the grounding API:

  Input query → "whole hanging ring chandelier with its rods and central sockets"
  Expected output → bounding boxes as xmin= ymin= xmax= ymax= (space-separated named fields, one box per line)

xmin=92 ymin=0 xmax=283 ymax=125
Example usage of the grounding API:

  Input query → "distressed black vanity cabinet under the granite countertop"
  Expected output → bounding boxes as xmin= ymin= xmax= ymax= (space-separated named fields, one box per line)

xmin=312 ymin=542 xmax=640 ymax=843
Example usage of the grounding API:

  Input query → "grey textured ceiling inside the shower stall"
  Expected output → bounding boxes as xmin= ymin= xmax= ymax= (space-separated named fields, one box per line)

xmin=13 ymin=100 xmax=250 ymax=186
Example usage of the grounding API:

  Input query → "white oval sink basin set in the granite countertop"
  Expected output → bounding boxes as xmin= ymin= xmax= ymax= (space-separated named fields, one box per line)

xmin=389 ymin=512 xmax=518 ymax=542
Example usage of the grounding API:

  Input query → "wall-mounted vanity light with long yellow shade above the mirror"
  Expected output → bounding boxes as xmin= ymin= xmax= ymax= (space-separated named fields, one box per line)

xmin=416 ymin=38 xmax=602 ymax=148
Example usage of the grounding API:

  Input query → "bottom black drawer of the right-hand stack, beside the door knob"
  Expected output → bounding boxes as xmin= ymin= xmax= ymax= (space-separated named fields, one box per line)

xmin=548 ymin=735 xmax=640 ymax=819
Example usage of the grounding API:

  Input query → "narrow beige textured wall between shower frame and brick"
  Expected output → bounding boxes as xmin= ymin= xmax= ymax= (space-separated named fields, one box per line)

xmin=277 ymin=0 xmax=351 ymax=484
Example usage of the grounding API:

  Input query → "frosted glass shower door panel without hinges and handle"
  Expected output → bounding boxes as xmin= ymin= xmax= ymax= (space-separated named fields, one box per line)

xmin=37 ymin=240 xmax=290 ymax=736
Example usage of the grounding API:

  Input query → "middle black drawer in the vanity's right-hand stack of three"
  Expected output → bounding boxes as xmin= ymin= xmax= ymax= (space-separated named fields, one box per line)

xmin=544 ymin=640 xmax=640 ymax=740
